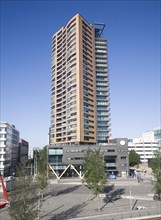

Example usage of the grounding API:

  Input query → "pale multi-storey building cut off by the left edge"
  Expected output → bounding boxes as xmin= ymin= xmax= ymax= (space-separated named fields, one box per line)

xmin=0 ymin=123 xmax=19 ymax=176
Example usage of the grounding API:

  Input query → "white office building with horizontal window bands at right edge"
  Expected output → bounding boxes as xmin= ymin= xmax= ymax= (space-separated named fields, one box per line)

xmin=128 ymin=128 xmax=161 ymax=164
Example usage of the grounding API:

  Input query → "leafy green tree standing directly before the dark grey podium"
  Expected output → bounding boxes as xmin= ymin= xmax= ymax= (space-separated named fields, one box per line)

xmin=83 ymin=149 xmax=107 ymax=210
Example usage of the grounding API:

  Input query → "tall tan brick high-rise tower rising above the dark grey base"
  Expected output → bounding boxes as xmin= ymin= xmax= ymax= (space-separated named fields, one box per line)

xmin=49 ymin=14 xmax=110 ymax=144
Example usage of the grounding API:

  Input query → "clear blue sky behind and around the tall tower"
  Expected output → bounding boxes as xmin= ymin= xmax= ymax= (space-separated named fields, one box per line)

xmin=0 ymin=0 xmax=161 ymax=147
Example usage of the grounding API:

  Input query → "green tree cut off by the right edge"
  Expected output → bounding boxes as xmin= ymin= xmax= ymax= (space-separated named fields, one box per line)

xmin=151 ymin=152 xmax=161 ymax=195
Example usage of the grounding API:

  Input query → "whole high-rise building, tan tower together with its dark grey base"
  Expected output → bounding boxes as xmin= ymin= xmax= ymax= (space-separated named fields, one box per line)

xmin=48 ymin=14 xmax=128 ymax=176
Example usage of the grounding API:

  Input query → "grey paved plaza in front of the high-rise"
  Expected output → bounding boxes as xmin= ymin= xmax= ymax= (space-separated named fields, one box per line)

xmin=0 ymin=178 xmax=161 ymax=220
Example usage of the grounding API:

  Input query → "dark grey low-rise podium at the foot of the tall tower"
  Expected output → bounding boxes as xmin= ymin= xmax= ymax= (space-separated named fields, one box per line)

xmin=48 ymin=138 xmax=129 ymax=176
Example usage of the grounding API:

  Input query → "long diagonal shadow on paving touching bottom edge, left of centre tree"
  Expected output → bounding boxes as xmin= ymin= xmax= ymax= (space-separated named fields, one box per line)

xmin=50 ymin=202 xmax=86 ymax=220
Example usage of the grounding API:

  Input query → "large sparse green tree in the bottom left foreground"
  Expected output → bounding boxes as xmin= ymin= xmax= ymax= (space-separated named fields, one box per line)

xmin=8 ymin=164 xmax=39 ymax=220
